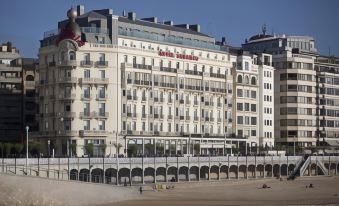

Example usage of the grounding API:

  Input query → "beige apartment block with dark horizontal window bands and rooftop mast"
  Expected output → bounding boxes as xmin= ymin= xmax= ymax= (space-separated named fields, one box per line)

xmin=242 ymin=29 xmax=319 ymax=146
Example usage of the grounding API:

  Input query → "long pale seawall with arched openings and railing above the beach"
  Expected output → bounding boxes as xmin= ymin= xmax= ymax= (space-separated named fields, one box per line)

xmin=0 ymin=156 xmax=339 ymax=185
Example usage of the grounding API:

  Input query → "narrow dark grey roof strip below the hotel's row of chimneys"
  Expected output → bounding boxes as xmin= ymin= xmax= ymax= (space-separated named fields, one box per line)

xmin=119 ymin=16 xmax=210 ymax=37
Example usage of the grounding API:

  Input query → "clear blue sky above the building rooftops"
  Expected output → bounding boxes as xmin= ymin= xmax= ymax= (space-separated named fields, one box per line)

xmin=0 ymin=0 xmax=339 ymax=57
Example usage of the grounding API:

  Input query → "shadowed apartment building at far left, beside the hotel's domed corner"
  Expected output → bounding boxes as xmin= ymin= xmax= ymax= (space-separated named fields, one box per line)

xmin=0 ymin=42 xmax=38 ymax=142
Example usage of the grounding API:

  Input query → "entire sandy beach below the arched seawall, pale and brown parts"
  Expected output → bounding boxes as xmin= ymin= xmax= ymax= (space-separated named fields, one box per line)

xmin=0 ymin=174 xmax=339 ymax=206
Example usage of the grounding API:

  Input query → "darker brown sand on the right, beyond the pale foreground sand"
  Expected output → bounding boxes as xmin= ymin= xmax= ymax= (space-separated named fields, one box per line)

xmin=102 ymin=177 xmax=339 ymax=206
